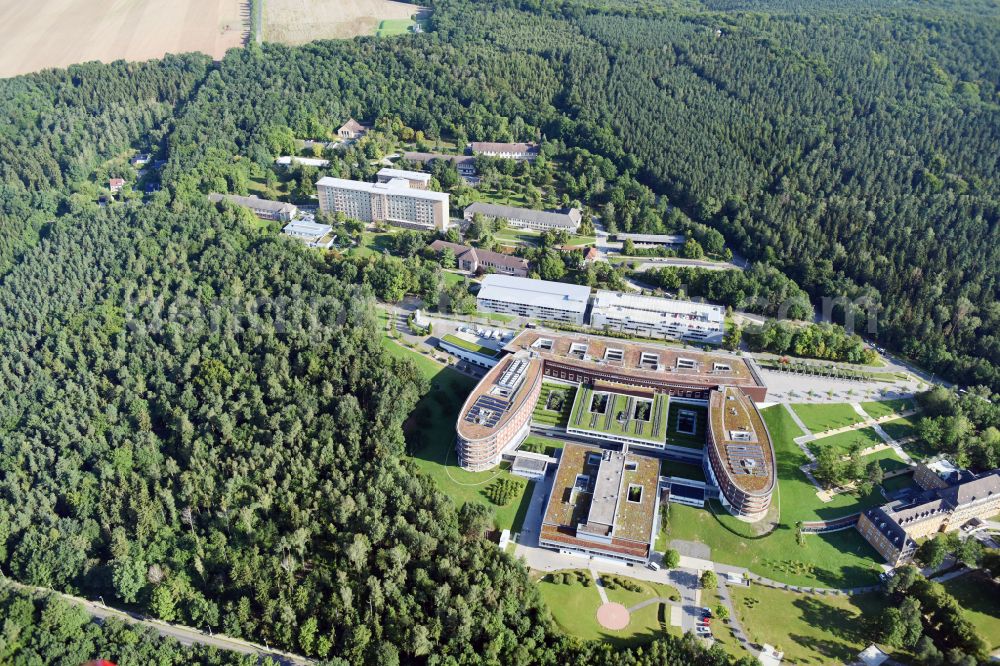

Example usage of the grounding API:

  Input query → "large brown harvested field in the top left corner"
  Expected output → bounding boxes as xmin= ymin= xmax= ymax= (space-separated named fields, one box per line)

xmin=0 ymin=0 xmax=249 ymax=77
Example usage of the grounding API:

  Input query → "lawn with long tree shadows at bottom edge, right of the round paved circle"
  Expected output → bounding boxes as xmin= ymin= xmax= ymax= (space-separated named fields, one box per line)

xmin=731 ymin=585 xmax=882 ymax=664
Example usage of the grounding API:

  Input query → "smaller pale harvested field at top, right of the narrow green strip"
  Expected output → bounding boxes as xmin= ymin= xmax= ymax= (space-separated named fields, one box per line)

xmin=264 ymin=0 xmax=422 ymax=44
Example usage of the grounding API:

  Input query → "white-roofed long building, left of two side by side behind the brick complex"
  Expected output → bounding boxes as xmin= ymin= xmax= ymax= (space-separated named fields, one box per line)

xmin=476 ymin=275 xmax=590 ymax=324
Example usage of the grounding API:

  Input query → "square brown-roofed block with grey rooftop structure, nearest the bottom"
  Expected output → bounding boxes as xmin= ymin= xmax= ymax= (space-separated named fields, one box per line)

xmin=538 ymin=443 xmax=660 ymax=564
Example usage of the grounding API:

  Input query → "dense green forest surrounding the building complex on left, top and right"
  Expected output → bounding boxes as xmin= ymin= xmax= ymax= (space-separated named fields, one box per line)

xmin=0 ymin=0 xmax=1000 ymax=665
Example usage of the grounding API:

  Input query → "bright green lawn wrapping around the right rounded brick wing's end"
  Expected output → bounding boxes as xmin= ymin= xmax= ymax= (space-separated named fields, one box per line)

xmin=667 ymin=405 xmax=884 ymax=587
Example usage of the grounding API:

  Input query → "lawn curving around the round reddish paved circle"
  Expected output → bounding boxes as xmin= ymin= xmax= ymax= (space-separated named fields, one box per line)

xmin=538 ymin=571 xmax=679 ymax=647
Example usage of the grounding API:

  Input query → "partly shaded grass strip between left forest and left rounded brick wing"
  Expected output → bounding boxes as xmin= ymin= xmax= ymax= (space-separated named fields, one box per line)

xmin=382 ymin=338 xmax=532 ymax=532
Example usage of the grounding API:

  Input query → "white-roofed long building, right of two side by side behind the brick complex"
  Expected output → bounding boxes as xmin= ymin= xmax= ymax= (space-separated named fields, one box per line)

xmin=590 ymin=290 xmax=726 ymax=344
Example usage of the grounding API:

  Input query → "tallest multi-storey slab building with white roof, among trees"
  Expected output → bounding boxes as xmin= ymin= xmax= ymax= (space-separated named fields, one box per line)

xmin=316 ymin=176 xmax=448 ymax=231
